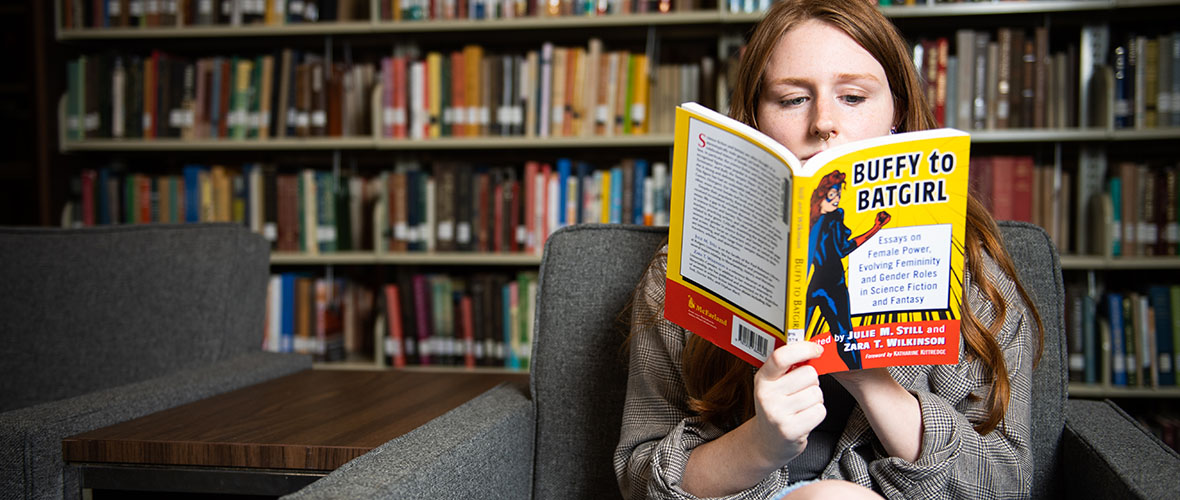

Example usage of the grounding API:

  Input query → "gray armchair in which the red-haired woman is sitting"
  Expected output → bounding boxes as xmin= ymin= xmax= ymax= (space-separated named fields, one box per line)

xmin=289 ymin=223 xmax=1180 ymax=499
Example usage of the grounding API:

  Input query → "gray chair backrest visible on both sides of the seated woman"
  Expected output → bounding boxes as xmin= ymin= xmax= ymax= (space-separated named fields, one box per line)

xmin=532 ymin=222 xmax=1068 ymax=499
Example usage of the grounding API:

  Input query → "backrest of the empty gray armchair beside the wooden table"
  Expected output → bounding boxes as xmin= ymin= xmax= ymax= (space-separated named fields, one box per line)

xmin=0 ymin=224 xmax=270 ymax=412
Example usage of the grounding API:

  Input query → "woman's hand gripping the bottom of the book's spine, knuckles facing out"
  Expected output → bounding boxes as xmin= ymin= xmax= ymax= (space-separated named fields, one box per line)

xmin=752 ymin=342 xmax=827 ymax=467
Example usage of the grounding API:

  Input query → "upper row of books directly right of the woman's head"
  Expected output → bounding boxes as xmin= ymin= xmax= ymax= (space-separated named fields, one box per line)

xmin=912 ymin=26 xmax=1180 ymax=130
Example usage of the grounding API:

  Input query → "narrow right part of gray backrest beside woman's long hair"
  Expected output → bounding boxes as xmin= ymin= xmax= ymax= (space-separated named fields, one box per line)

xmin=999 ymin=221 xmax=1069 ymax=499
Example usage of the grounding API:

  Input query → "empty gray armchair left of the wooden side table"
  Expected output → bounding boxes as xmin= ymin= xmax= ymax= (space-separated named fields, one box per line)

xmin=0 ymin=224 xmax=312 ymax=499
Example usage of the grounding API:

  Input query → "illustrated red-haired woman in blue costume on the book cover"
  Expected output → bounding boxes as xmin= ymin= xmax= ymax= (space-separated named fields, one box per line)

xmin=806 ymin=170 xmax=890 ymax=370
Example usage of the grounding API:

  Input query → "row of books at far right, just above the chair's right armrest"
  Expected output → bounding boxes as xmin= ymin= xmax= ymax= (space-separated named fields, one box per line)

xmin=1066 ymin=284 xmax=1180 ymax=388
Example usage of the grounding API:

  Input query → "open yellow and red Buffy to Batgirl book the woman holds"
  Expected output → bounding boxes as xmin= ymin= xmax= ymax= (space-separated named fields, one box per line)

xmin=664 ymin=103 xmax=970 ymax=374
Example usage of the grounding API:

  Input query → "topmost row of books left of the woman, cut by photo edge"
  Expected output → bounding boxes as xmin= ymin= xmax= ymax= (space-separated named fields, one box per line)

xmin=61 ymin=0 xmax=707 ymax=29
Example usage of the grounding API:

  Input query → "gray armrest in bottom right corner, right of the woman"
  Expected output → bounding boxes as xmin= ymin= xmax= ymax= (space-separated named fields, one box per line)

xmin=1061 ymin=400 xmax=1180 ymax=499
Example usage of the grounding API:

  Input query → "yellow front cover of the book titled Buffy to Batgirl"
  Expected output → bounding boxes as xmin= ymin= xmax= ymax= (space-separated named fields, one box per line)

xmin=788 ymin=129 xmax=971 ymax=373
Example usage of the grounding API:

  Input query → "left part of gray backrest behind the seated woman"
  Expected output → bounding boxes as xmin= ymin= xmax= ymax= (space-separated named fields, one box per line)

xmin=531 ymin=224 xmax=668 ymax=499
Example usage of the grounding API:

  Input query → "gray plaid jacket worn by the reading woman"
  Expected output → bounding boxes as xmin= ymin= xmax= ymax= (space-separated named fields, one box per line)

xmin=615 ymin=249 xmax=1038 ymax=500
